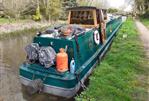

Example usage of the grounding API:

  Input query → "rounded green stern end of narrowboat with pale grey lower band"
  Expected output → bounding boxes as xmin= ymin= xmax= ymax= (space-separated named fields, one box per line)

xmin=20 ymin=64 xmax=80 ymax=98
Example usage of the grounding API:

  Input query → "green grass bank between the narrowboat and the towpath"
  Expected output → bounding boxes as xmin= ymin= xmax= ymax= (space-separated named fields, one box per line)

xmin=75 ymin=19 xmax=149 ymax=101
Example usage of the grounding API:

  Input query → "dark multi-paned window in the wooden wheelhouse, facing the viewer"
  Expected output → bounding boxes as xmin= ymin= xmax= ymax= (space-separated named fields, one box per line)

xmin=70 ymin=11 xmax=94 ymax=25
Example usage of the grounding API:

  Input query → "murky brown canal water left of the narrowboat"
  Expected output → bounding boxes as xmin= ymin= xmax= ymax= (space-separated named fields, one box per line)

xmin=0 ymin=34 xmax=74 ymax=101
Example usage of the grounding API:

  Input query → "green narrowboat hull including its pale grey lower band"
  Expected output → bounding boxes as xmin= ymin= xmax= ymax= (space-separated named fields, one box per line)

xmin=20 ymin=18 xmax=122 ymax=98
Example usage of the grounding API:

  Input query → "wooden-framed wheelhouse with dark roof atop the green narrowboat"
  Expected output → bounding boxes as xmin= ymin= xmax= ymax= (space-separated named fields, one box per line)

xmin=68 ymin=7 xmax=107 ymax=28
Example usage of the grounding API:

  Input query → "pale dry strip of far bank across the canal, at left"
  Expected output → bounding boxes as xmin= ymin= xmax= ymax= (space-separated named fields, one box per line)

xmin=0 ymin=21 xmax=49 ymax=34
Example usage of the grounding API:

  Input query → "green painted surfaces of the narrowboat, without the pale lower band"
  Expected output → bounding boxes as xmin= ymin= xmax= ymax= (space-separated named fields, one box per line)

xmin=20 ymin=18 xmax=122 ymax=88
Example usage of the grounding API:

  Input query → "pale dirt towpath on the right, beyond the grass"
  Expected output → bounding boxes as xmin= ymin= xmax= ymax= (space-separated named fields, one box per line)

xmin=136 ymin=21 xmax=149 ymax=101
